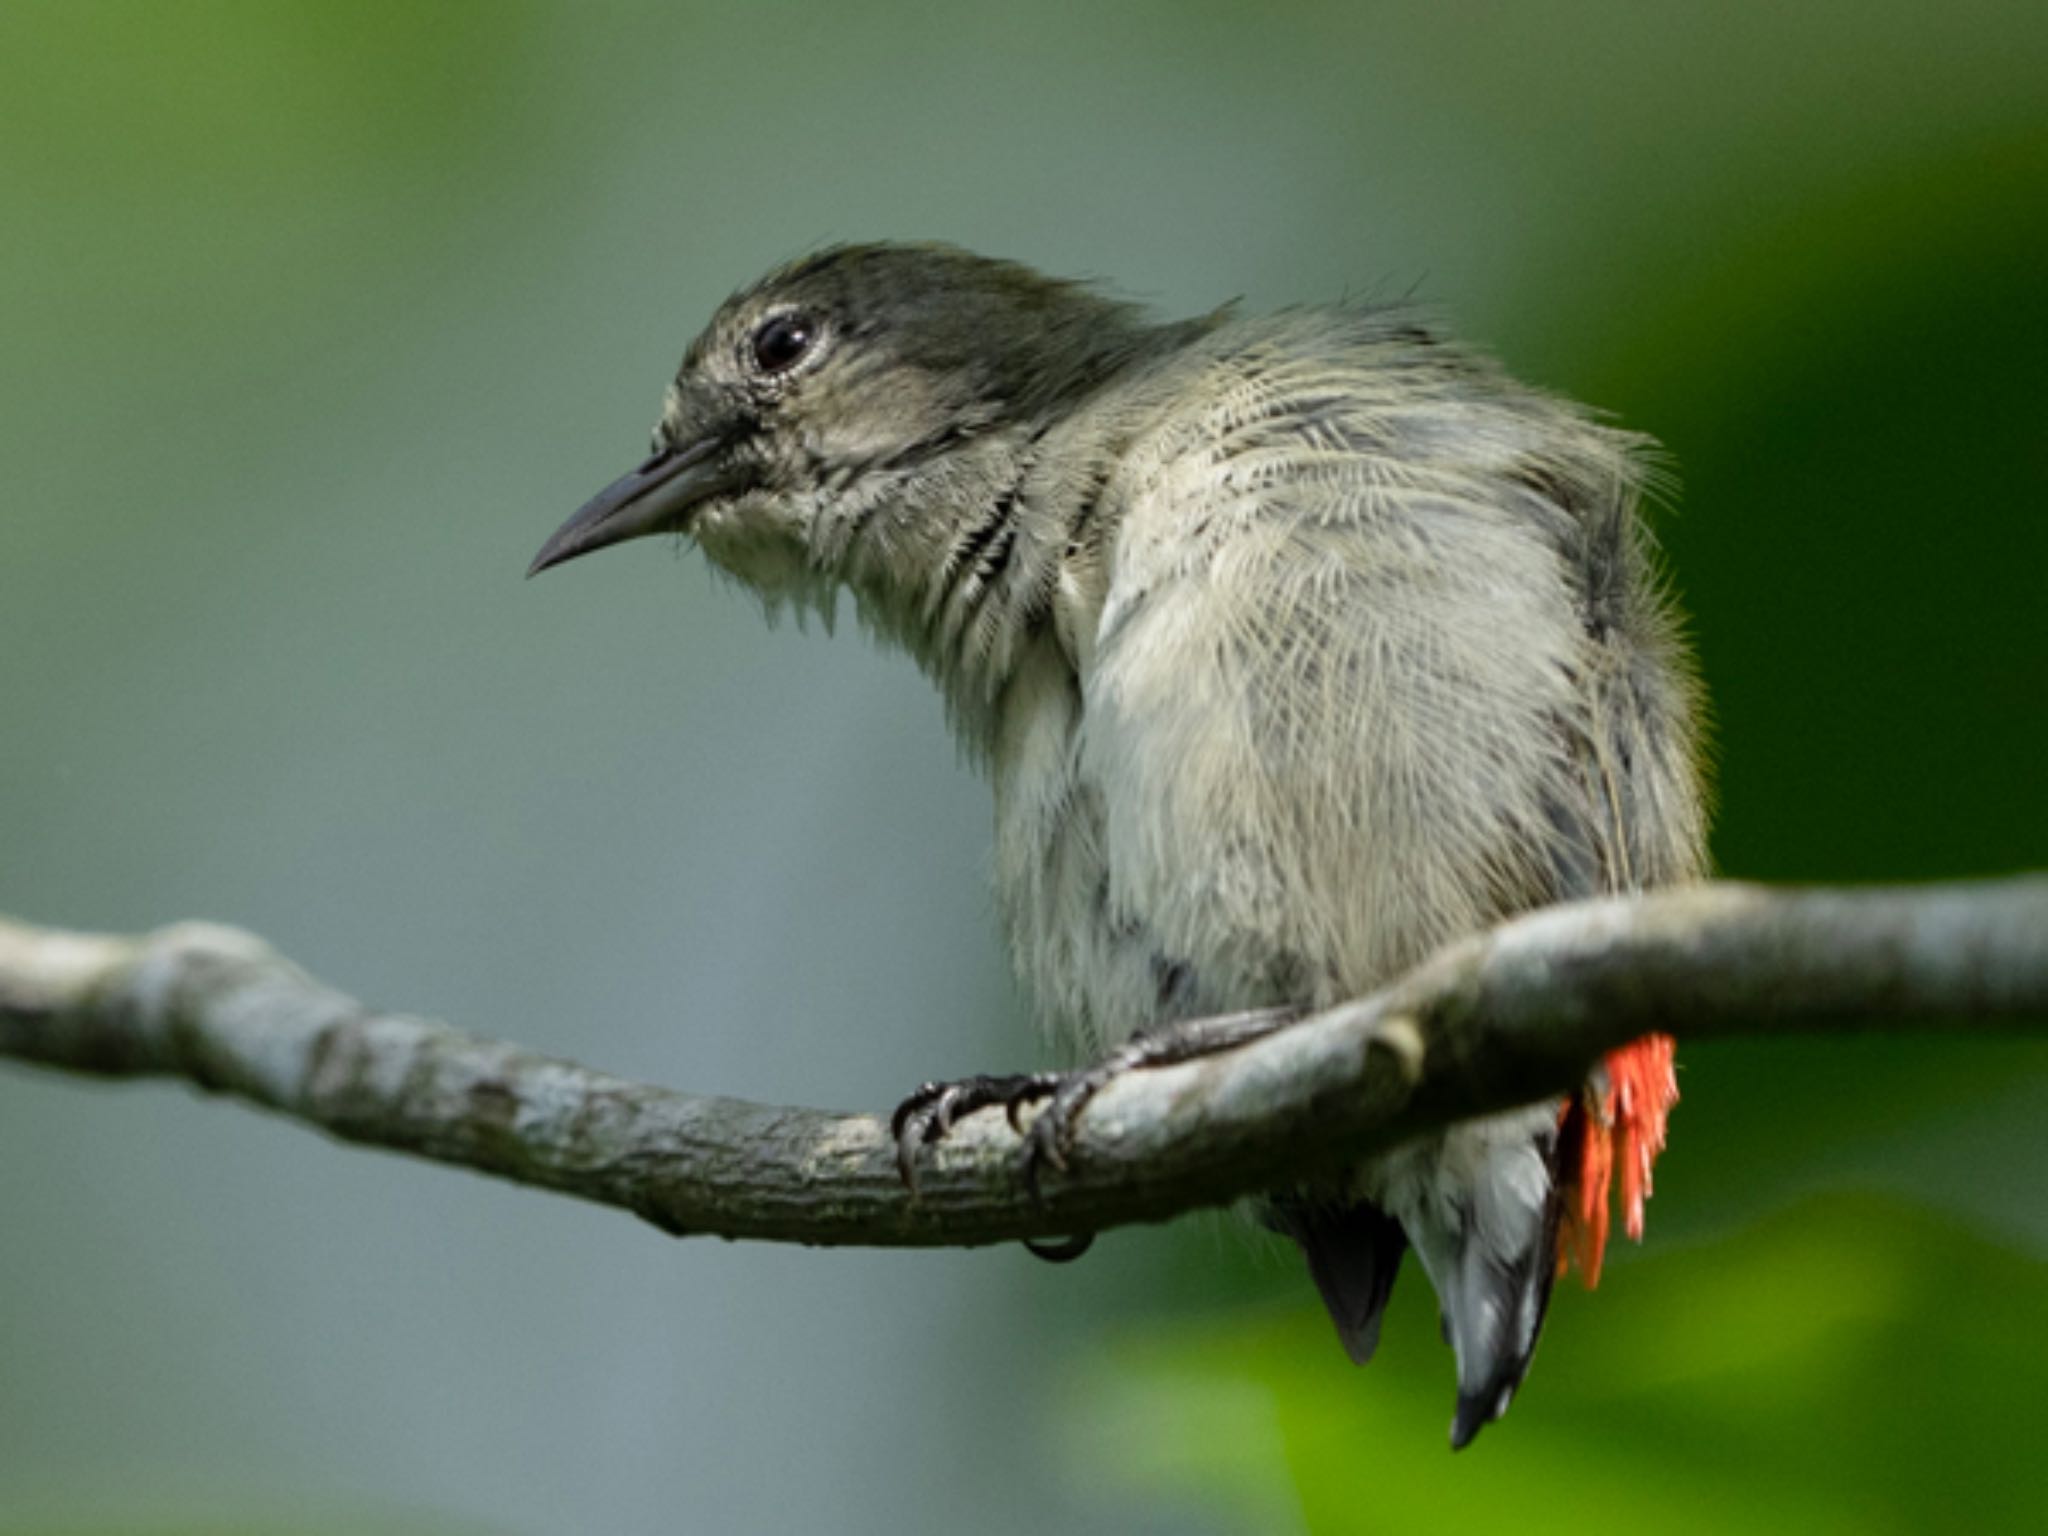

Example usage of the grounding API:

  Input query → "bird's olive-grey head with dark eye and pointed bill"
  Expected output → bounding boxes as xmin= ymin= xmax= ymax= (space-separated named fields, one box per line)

xmin=528 ymin=244 xmax=1149 ymax=598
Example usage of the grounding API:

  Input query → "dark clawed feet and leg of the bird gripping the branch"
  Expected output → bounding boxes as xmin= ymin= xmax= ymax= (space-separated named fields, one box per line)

xmin=889 ymin=1008 xmax=1300 ymax=1212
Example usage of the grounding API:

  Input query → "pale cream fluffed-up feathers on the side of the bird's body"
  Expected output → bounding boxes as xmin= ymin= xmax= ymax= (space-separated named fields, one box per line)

xmin=1083 ymin=319 xmax=1671 ymax=1004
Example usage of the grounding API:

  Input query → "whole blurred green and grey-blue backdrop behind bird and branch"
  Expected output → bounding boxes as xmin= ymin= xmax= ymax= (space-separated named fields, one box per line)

xmin=0 ymin=0 xmax=2048 ymax=1536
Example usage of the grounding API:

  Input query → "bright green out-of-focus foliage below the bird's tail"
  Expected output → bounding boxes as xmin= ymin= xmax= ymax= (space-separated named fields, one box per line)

xmin=1065 ymin=1198 xmax=2048 ymax=1536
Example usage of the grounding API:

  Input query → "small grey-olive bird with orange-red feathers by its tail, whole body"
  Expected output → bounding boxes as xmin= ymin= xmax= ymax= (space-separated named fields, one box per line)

xmin=530 ymin=244 xmax=1706 ymax=1448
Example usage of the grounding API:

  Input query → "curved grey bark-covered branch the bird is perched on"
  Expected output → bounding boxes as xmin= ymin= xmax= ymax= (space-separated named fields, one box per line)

xmin=0 ymin=874 xmax=2048 ymax=1245
